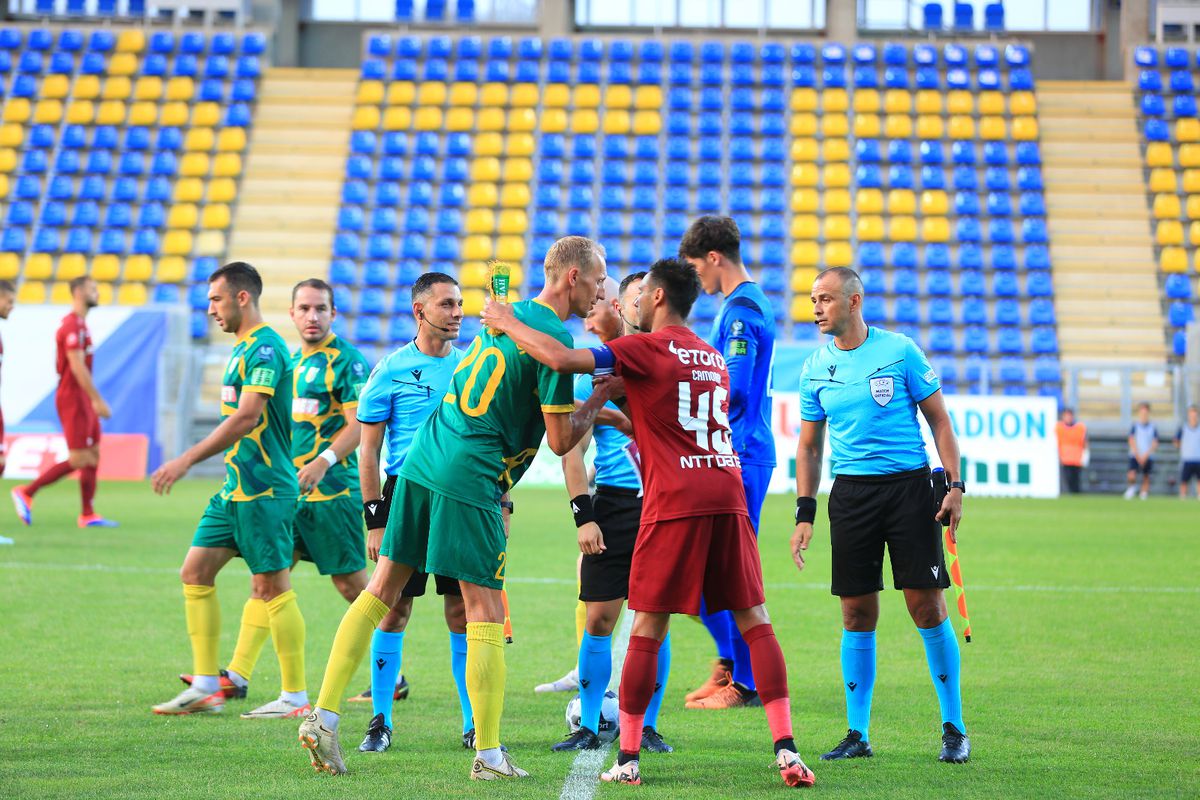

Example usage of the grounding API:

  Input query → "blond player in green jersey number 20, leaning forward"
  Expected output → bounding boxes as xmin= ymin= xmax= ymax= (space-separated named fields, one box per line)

xmin=300 ymin=236 xmax=611 ymax=780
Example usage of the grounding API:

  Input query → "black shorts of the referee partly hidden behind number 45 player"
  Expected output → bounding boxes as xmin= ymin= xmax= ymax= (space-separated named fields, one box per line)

xmin=580 ymin=486 xmax=642 ymax=602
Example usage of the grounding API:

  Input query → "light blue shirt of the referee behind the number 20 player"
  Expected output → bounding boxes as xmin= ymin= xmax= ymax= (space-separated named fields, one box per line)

xmin=358 ymin=342 xmax=463 ymax=475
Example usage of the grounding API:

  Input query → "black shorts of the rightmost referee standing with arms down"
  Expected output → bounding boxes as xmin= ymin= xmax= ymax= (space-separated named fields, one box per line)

xmin=829 ymin=468 xmax=950 ymax=597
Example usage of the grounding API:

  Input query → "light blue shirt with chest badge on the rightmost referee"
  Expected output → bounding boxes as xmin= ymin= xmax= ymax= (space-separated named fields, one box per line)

xmin=800 ymin=327 xmax=942 ymax=475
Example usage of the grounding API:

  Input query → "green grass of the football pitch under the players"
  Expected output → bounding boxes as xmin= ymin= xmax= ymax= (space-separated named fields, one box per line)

xmin=0 ymin=481 xmax=1200 ymax=800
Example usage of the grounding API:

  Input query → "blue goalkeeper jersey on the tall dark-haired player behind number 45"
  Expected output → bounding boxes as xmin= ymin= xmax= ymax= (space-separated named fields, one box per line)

xmin=708 ymin=281 xmax=775 ymax=467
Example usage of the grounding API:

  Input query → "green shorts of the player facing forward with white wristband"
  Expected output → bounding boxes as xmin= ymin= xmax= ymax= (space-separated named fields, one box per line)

xmin=292 ymin=497 xmax=367 ymax=575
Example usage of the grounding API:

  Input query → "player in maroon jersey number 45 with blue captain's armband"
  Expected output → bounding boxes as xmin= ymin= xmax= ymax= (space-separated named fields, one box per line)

xmin=482 ymin=259 xmax=815 ymax=786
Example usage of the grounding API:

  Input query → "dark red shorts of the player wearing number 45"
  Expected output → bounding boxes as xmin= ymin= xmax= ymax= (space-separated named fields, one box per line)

xmin=629 ymin=513 xmax=763 ymax=614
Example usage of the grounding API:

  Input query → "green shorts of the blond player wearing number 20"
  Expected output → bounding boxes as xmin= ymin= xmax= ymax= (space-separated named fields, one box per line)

xmin=379 ymin=477 xmax=508 ymax=589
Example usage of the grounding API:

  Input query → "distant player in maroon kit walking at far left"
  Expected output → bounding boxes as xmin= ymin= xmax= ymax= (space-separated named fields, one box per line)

xmin=12 ymin=276 xmax=116 ymax=528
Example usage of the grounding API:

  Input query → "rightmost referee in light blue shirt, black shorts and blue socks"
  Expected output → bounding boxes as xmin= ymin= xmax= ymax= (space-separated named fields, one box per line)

xmin=792 ymin=267 xmax=971 ymax=764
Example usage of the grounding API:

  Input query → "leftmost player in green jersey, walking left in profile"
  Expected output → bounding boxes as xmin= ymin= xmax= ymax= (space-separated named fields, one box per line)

xmin=150 ymin=261 xmax=310 ymax=717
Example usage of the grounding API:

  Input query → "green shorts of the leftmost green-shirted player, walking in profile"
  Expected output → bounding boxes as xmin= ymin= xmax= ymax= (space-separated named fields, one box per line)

xmin=192 ymin=494 xmax=296 ymax=575
